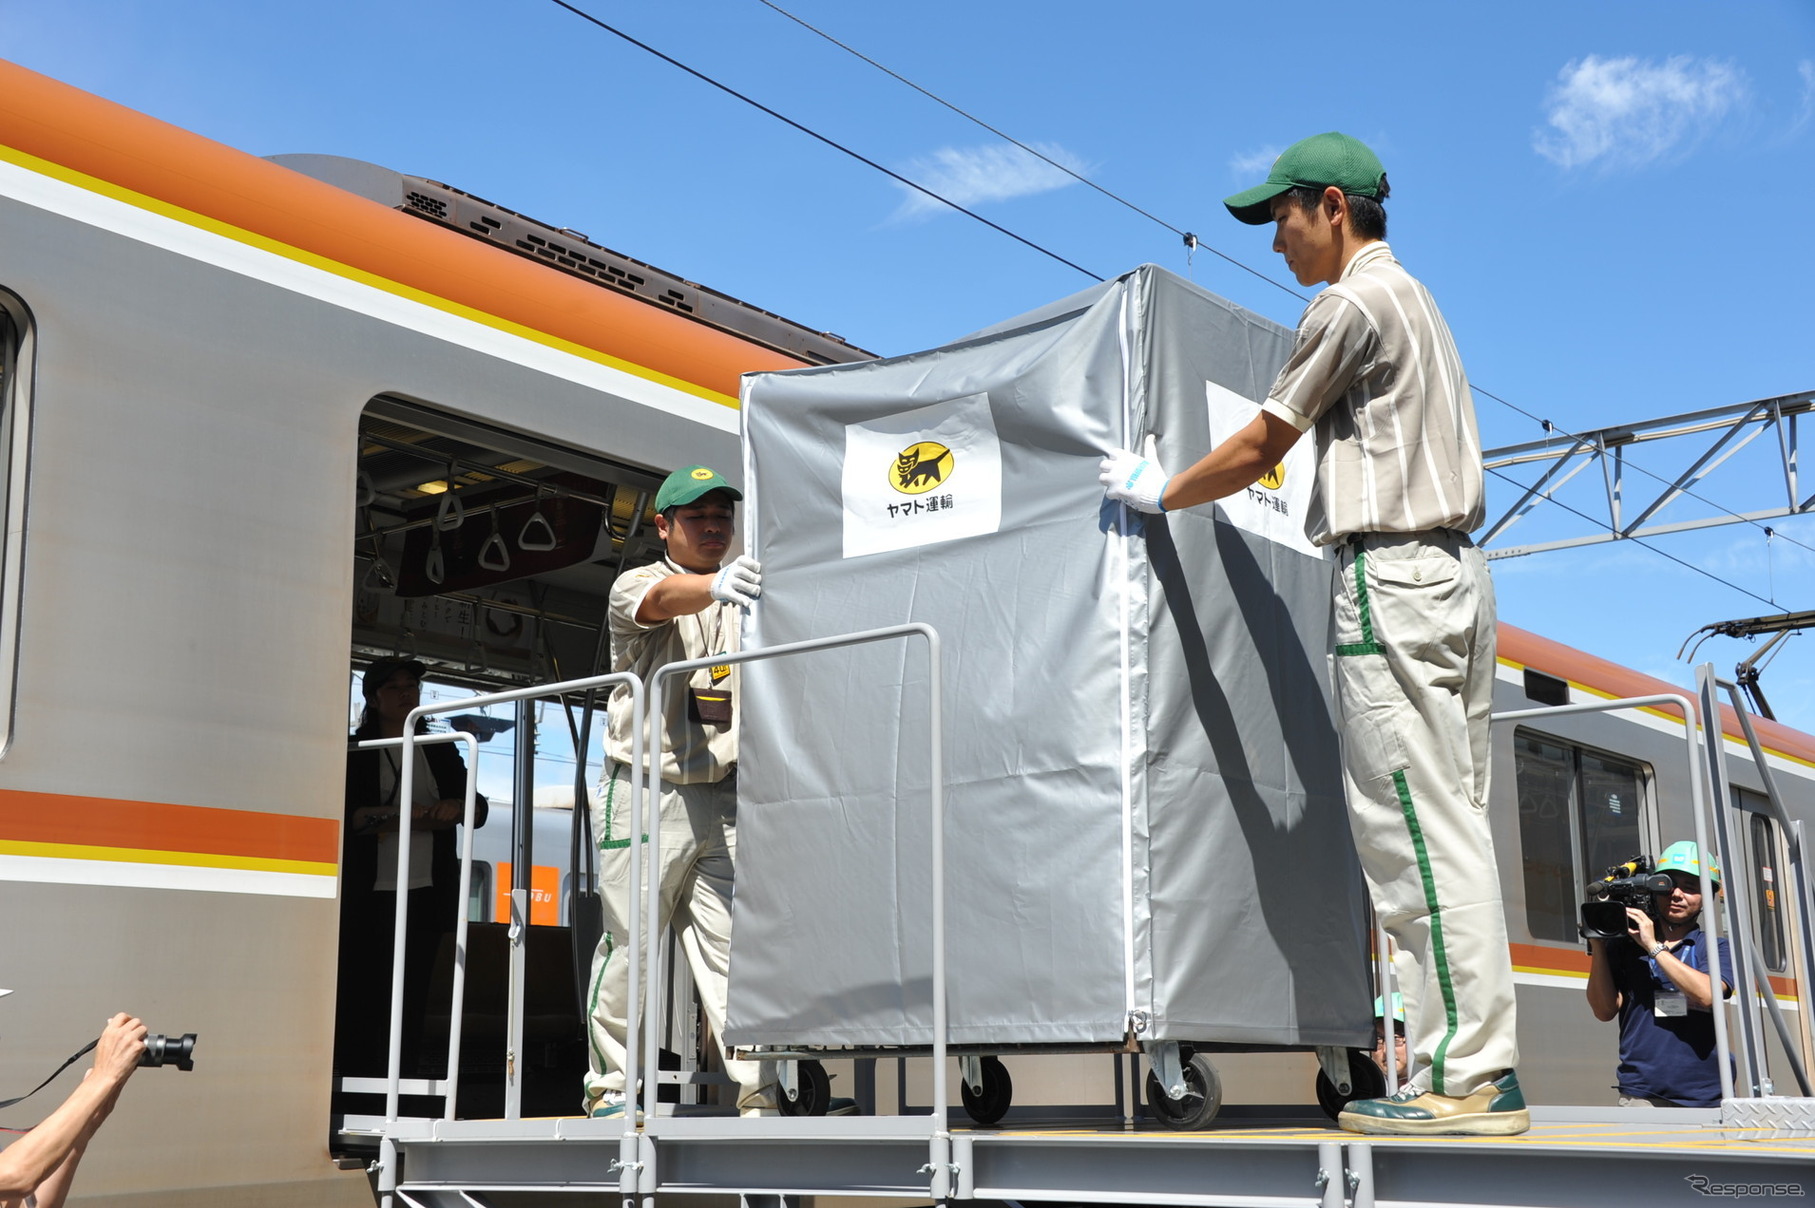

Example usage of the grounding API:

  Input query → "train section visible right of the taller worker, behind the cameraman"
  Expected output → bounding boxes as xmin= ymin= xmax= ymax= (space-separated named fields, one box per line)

xmin=1492 ymin=624 xmax=1815 ymax=1105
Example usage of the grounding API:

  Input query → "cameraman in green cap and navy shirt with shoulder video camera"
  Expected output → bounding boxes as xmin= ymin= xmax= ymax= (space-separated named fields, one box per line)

xmin=1588 ymin=842 xmax=1733 ymax=1106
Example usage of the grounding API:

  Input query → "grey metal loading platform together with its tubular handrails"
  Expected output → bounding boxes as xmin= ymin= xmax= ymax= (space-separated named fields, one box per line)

xmin=343 ymin=663 xmax=1815 ymax=1208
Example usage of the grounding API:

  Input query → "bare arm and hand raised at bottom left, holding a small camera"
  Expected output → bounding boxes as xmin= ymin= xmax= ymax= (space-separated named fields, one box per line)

xmin=0 ymin=1014 xmax=145 ymax=1208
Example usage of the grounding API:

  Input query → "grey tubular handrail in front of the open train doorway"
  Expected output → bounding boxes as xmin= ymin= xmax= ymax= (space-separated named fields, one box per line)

xmin=397 ymin=671 xmax=644 ymax=1155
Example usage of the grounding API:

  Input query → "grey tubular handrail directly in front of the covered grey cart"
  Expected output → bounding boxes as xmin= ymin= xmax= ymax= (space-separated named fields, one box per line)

xmin=642 ymin=620 xmax=951 ymax=1199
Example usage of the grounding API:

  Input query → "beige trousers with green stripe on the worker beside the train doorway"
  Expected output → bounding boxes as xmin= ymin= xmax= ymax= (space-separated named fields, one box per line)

xmin=586 ymin=764 xmax=777 ymax=1110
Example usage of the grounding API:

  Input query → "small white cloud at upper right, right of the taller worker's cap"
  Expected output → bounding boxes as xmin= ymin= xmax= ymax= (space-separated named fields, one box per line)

xmin=1532 ymin=54 xmax=1750 ymax=169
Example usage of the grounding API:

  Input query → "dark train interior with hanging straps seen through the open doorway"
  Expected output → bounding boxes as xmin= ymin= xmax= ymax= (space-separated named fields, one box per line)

xmin=334 ymin=397 xmax=686 ymax=1148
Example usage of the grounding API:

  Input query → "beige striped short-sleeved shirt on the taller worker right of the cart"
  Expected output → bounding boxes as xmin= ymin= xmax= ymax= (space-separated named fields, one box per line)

xmin=1261 ymin=241 xmax=1485 ymax=546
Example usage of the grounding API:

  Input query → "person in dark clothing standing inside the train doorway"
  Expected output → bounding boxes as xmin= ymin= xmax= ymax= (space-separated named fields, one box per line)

xmin=334 ymin=658 xmax=486 ymax=1077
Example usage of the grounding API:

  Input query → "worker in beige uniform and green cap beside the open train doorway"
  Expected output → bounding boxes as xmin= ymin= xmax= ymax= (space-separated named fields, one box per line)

xmin=586 ymin=466 xmax=777 ymax=1117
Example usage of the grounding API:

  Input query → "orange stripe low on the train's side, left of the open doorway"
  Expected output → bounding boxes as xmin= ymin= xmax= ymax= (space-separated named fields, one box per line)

xmin=0 ymin=789 xmax=339 ymax=865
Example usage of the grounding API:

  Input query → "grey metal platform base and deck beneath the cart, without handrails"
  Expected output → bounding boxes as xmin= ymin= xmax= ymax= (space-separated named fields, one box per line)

xmin=364 ymin=1108 xmax=1815 ymax=1208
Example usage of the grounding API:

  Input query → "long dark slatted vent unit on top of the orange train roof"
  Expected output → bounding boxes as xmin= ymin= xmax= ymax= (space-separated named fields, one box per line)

xmin=269 ymin=154 xmax=875 ymax=365
